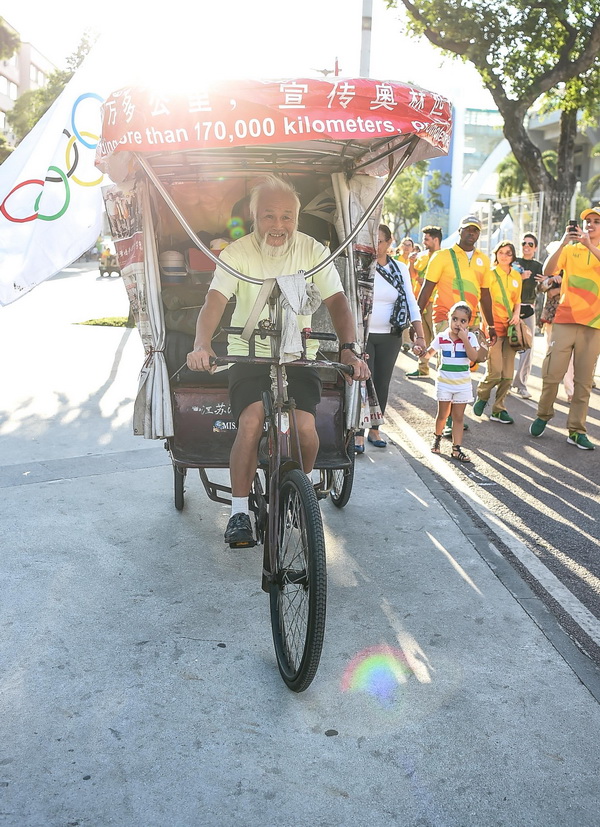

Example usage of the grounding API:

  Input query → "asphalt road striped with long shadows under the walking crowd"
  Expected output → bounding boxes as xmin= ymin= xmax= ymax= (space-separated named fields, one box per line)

xmin=382 ymin=337 xmax=600 ymax=663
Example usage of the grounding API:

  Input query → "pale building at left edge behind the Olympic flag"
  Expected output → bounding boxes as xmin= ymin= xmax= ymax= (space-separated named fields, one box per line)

xmin=0 ymin=20 xmax=56 ymax=143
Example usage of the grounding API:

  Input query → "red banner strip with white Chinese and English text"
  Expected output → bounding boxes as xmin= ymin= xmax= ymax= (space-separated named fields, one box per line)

xmin=97 ymin=78 xmax=452 ymax=167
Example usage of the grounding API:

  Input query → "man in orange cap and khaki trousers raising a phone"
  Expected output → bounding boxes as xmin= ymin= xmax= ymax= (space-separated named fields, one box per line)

xmin=529 ymin=205 xmax=600 ymax=451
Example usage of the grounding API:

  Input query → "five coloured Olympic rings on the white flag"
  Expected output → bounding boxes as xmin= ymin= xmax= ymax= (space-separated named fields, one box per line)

xmin=0 ymin=92 xmax=104 ymax=224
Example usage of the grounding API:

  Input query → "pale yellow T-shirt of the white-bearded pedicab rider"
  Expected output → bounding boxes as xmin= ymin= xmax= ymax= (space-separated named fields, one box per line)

xmin=210 ymin=233 xmax=344 ymax=359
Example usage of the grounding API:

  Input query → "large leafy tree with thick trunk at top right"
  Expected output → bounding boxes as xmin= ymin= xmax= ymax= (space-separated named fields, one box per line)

xmin=386 ymin=0 xmax=600 ymax=246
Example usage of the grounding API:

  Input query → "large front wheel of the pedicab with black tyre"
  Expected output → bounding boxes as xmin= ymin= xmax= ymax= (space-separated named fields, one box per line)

xmin=270 ymin=468 xmax=327 ymax=692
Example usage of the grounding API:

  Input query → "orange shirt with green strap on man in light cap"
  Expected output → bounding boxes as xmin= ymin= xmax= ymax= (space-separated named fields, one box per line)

xmin=426 ymin=244 xmax=490 ymax=323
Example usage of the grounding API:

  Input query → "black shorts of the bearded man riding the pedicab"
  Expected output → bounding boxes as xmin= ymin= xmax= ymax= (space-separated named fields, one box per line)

xmin=227 ymin=362 xmax=322 ymax=422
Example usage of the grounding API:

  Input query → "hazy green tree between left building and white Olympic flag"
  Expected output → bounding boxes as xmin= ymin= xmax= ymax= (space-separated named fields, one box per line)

xmin=6 ymin=32 xmax=94 ymax=143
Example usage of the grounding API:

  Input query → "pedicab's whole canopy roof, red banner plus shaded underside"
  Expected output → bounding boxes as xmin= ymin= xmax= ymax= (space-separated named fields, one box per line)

xmin=96 ymin=78 xmax=452 ymax=181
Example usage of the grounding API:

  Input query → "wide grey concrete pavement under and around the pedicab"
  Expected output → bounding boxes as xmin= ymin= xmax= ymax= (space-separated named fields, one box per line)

xmin=0 ymin=268 xmax=600 ymax=827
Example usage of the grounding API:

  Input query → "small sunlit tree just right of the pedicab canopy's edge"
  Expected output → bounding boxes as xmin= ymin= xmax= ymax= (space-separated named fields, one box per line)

xmin=383 ymin=161 xmax=450 ymax=236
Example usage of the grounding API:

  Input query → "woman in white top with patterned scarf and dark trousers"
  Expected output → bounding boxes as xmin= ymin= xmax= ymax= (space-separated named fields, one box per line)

xmin=355 ymin=224 xmax=426 ymax=454
